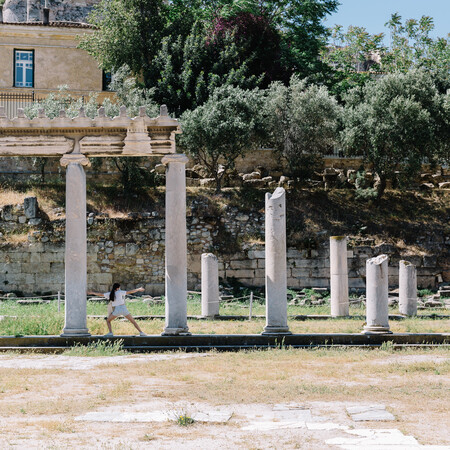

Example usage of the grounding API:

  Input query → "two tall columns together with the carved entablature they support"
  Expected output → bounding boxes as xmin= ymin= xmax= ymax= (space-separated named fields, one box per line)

xmin=0 ymin=105 xmax=189 ymax=336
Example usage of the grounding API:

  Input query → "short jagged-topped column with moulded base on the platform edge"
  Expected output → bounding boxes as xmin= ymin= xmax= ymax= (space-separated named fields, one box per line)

xmin=364 ymin=255 xmax=391 ymax=334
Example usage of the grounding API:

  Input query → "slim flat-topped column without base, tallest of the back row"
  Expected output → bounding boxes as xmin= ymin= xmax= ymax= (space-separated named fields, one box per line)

xmin=330 ymin=236 xmax=349 ymax=317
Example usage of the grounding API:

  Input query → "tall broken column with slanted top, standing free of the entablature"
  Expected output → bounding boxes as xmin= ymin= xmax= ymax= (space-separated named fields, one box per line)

xmin=262 ymin=188 xmax=291 ymax=334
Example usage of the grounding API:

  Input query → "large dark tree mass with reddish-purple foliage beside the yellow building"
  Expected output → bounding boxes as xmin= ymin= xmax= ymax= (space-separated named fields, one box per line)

xmin=80 ymin=0 xmax=338 ymax=112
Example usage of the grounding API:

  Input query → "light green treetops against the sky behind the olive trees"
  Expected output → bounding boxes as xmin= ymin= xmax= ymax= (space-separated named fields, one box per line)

xmin=321 ymin=13 xmax=450 ymax=98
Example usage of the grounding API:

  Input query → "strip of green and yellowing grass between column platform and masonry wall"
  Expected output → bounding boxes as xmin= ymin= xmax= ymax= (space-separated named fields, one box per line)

xmin=0 ymin=295 xmax=450 ymax=336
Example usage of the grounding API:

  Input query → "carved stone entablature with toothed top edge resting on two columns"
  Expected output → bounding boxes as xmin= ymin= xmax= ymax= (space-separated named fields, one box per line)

xmin=0 ymin=107 xmax=181 ymax=157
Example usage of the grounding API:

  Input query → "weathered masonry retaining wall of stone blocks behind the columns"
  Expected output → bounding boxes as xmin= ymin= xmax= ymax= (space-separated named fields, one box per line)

xmin=0 ymin=205 xmax=450 ymax=295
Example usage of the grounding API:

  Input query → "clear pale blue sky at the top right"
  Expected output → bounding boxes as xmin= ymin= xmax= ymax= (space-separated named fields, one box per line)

xmin=325 ymin=0 xmax=450 ymax=44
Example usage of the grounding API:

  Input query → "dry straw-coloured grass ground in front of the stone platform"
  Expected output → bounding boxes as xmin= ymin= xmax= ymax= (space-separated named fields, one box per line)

xmin=0 ymin=348 xmax=450 ymax=449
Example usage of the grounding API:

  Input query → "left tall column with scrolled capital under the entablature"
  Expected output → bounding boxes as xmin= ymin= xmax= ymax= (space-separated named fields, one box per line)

xmin=60 ymin=153 xmax=89 ymax=336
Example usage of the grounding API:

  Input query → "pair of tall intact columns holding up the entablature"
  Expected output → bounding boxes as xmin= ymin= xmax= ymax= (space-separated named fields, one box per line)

xmin=61 ymin=153 xmax=189 ymax=336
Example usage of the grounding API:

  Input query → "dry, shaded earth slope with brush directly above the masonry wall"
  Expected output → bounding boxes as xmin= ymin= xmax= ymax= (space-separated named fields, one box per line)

xmin=0 ymin=182 xmax=450 ymax=251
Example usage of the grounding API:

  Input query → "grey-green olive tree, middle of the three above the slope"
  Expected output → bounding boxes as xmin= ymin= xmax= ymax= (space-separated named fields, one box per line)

xmin=267 ymin=76 xmax=341 ymax=178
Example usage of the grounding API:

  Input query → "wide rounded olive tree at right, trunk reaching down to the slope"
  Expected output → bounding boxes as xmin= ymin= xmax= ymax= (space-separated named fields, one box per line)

xmin=341 ymin=69 xmax=449 ymax=198
